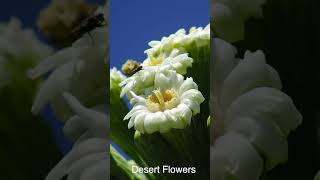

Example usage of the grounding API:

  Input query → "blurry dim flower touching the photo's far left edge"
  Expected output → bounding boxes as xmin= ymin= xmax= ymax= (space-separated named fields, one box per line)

xmin=0 ymin=18 xmax=52 ymax=88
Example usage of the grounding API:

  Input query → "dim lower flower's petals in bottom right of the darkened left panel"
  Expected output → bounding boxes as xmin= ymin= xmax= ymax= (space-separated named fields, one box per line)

xmin=46 ymin=93 xmax=109 ymax=180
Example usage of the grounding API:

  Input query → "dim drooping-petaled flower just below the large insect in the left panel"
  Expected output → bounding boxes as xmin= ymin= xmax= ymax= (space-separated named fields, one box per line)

xmin=28 ymin=4 xmax=108 ymax=121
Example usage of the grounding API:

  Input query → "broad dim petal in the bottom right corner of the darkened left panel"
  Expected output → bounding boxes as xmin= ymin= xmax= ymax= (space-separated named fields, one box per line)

xmin=45 ymin=138 xmax=109 ymax=180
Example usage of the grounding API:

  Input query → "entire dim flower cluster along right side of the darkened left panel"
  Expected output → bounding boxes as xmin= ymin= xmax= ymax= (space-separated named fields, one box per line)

xmin=28 ymin=3 xmax=109 ymax=180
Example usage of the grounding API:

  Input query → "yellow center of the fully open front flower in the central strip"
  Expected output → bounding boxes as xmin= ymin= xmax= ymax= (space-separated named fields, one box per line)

xmin=146 ymin=89 xmax=179 ymax=112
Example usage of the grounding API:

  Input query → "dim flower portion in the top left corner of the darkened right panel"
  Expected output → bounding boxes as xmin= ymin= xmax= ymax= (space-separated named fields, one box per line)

xmin=211 ymin=0 xmax=266 ymax=42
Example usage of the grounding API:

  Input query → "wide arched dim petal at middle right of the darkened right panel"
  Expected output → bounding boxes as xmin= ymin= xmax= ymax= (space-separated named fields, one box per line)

xmin=225 ymin=87 xmax=302 ymax=136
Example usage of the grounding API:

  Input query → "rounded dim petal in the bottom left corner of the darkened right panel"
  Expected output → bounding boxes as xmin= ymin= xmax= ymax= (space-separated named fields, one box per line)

xmin=210 ymin=133 xmax=263 ymax=180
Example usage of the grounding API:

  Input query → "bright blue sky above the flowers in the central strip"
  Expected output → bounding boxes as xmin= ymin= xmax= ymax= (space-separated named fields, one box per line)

xmin=110 ymin=0 xmax=210 ymax=68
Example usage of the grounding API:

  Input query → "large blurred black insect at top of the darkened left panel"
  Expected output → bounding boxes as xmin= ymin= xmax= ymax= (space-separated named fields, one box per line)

xmin=72 ymin=13 xmax=106 ymax=41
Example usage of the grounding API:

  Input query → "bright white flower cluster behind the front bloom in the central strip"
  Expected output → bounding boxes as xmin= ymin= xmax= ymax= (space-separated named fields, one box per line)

xmin=121 ymin=25 xmax=210 ymax=96
